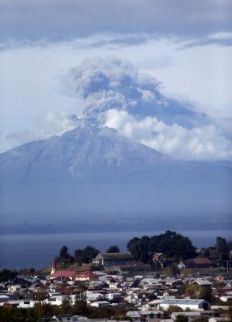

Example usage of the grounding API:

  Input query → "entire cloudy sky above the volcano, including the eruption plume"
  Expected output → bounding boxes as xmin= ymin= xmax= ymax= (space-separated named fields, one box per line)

xmin=0 ymin=0 xmax=232 ymax=160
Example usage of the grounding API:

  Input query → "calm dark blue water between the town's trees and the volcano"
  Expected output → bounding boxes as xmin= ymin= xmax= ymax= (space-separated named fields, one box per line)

xmin=0 ymin=231 xmax=232 ymax=269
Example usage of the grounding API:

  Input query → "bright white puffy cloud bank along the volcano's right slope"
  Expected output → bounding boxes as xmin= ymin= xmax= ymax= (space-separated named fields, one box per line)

xmin=104 ymin=109 xmax=232 ymax=160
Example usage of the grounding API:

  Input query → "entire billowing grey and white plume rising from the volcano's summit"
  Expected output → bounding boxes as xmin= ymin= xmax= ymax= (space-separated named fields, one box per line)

xmin=63 ymin=59 xmax=232 ymax=160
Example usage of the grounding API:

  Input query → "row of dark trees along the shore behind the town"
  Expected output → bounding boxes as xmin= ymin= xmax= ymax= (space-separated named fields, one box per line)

xmin=56 ymin=230 xmax=232 ymax=265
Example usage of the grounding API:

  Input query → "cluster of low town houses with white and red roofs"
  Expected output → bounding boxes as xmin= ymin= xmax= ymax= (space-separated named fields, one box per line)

xmin=0 ymin=253 xmax=232 ymax=322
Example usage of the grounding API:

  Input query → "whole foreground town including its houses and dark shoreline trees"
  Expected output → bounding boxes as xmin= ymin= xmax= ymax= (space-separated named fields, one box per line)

xmin=0 ymin=231 xmax=232 ymax=322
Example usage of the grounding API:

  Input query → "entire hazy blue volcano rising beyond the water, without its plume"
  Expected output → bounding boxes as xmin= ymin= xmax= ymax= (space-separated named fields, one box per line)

xmin=0 ymin=126 xmax=232 ymax=230
